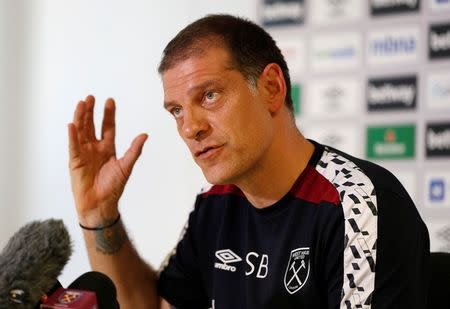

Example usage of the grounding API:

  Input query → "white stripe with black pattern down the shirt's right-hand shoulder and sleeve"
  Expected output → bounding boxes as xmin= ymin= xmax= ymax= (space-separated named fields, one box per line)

xmin=316 ymin=148 xmax=378 ymax=309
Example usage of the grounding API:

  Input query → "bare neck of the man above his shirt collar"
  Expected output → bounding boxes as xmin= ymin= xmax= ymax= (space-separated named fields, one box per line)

xmin=235 ymin=120 xmax=314 ymax=208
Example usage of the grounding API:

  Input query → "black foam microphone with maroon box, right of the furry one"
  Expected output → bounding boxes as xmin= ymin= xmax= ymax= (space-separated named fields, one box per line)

xmin=41 ymin=271 xmax=120 ymax=309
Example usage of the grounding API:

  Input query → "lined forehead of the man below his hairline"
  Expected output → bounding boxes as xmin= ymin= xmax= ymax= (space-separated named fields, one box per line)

xmin=162 ymin=47 xmax=233 ymax=98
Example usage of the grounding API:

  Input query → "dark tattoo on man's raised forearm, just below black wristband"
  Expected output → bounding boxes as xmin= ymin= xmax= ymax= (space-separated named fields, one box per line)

xmin=95 ymin=221 xmax=126 ymax=255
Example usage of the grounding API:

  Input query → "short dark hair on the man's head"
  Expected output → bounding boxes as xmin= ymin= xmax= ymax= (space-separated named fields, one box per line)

xmin=158 ymin=14 xmax=293 ymax=112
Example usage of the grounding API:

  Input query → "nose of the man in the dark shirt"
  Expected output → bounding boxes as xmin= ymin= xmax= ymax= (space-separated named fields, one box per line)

xmin=180 ymin=108 xmax=209 ymax=140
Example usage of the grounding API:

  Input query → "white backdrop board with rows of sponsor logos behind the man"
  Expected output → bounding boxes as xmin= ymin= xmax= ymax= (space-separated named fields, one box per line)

xmin=257 ymin=0 xmax=450 ymax=252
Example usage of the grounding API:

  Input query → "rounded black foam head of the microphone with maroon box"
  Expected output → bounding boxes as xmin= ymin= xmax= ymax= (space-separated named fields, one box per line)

xmin=67 ymin=271 xmax=120 ymax=309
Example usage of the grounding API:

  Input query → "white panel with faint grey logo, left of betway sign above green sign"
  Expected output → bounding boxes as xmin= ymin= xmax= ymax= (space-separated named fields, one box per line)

xmin=304 ymin=78 xmax=363 ymax=119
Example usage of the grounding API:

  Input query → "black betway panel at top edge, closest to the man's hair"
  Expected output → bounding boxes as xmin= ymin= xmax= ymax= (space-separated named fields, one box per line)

xmin=262 ymin=2 xmax=305 ymax=23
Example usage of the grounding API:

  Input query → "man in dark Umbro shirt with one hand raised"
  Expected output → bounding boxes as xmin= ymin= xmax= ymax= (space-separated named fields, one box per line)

xmin=69 ymin=15 xmax=429 ymax=309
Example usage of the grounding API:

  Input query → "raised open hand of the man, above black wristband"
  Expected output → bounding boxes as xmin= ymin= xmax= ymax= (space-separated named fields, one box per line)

xmin=68 ymin=96 xmax=147 ymax=226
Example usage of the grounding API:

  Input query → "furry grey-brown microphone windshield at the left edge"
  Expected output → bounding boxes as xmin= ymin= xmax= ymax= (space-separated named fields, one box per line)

xmin=0 ymin=219 xmax=72 ymax=309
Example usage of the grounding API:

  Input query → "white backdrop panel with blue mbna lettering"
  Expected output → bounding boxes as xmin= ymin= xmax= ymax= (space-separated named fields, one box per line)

xmin=367 ymin=26 xmax=420 ymax=66
